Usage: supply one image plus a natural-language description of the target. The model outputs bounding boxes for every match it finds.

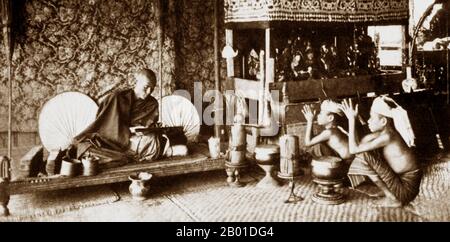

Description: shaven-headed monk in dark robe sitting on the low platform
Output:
[74,69,187,164]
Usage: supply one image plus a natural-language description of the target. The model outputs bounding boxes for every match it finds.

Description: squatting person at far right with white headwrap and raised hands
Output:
[342,96,422,207]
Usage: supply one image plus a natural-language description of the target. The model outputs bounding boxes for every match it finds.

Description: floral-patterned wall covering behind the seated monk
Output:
[0,0,175,132]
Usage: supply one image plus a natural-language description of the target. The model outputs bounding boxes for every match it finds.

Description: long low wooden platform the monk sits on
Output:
[0,144,225,216]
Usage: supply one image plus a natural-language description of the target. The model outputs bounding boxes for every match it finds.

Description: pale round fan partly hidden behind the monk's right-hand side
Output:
[161,95,200,141]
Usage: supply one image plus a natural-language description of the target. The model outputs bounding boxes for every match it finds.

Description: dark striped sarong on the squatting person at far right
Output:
[348,150,422,205]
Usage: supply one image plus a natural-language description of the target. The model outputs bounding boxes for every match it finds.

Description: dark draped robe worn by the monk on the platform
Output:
[74,89,166,163]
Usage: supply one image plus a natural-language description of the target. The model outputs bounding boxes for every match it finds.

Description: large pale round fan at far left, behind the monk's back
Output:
[39,92,98,150]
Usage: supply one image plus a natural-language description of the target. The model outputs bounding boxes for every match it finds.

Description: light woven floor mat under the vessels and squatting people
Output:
[165,162,450,222]
